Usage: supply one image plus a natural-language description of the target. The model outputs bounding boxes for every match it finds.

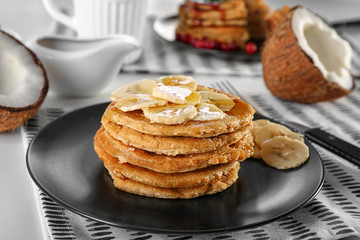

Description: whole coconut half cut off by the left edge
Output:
[0,30,49,132]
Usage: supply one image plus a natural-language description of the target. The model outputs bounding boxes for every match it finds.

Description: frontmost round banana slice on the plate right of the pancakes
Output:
[261,136,309,169]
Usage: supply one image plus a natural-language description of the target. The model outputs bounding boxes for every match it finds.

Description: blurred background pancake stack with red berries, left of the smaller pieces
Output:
[176,0,250,50]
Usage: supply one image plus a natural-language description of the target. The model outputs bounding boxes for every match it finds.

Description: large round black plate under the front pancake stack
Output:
[27,103,324,233]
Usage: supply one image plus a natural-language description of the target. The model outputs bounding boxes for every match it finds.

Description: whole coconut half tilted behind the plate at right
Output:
[262,6,354,103]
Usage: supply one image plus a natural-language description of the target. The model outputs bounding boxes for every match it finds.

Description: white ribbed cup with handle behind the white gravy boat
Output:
[42,0,148,63]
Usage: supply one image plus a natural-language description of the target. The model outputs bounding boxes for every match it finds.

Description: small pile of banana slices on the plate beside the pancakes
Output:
[251,119,309,169]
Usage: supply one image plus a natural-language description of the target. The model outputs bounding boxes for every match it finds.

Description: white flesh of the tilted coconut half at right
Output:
[291,8,353,90]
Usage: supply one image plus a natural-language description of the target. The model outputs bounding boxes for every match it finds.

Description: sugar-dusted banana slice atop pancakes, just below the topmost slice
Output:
[152,86,200,105]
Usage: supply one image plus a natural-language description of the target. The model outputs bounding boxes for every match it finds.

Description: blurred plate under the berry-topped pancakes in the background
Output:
[153,14,262,61]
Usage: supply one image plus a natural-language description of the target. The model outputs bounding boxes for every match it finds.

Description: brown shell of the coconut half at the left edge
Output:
[0,30,49,132]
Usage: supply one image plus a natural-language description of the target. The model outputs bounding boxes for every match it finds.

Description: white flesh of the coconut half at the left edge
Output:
[0,33,44,108]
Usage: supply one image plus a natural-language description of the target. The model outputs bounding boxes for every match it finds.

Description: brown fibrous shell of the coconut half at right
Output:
[262,6,354,103]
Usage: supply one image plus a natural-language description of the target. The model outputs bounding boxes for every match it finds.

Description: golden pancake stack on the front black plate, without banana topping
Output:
[94,87,254,199]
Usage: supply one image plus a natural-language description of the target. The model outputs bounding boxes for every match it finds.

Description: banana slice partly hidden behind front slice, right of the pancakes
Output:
[254,122,304,148]
